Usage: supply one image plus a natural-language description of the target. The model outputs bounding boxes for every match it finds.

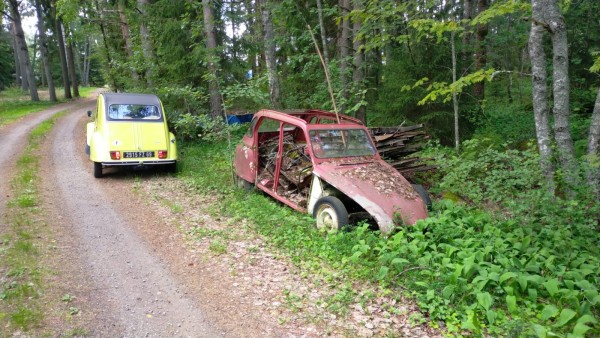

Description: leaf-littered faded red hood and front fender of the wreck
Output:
[313,160,427,234]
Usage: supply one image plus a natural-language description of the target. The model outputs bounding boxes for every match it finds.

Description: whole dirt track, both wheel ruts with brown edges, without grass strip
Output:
[0,100,288,337]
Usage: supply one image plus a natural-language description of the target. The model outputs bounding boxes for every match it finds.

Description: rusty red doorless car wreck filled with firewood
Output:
[235,110,427,235]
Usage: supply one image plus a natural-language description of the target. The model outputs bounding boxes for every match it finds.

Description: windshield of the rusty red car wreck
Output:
[309,129,375,158]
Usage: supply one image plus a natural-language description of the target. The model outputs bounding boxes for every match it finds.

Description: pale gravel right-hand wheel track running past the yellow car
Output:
[47,104,222,337]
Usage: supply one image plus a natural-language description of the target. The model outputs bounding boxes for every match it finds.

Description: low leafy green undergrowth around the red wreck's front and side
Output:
[181,131,600,337]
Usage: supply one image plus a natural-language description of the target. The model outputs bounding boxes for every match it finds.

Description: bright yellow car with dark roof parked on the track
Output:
[86,93,177,178]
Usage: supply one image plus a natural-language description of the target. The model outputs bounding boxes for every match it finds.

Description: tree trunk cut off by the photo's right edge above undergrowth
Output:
[587,88,600,201]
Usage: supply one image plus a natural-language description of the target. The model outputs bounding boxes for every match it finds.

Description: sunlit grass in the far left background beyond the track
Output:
[0,87,95,127]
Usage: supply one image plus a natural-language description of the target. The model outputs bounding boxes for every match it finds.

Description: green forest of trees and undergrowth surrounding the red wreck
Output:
[0,0,600,337]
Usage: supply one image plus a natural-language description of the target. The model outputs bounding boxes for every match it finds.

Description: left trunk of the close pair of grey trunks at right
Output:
[529,0,555,192]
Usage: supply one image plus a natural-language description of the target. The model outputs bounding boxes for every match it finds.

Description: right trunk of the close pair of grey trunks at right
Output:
[543,0,580,197]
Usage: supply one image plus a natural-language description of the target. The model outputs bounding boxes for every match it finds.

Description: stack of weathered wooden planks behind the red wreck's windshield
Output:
[369,124,435,176]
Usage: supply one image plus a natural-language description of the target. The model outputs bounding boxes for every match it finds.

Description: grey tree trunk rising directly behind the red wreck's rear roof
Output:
[260,0,281,108]
